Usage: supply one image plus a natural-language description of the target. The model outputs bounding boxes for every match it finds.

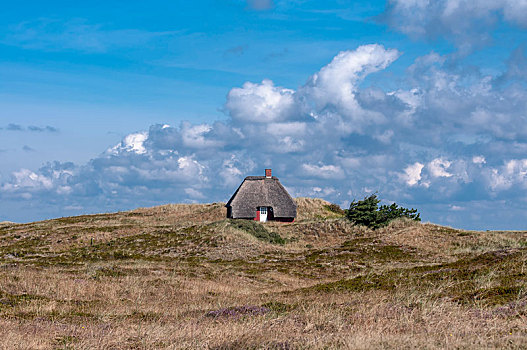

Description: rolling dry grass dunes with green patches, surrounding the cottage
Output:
[0,198,527,349]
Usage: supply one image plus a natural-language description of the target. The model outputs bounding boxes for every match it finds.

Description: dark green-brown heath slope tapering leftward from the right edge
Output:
[307,247,527,306]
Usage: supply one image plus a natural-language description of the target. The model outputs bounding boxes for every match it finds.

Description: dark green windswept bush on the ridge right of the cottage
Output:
[346,194,421,230]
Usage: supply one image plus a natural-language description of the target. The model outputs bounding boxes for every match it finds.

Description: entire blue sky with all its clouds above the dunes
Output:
[0,0,527,229]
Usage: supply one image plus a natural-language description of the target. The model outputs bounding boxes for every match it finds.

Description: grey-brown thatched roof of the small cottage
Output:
[226,176,296,219]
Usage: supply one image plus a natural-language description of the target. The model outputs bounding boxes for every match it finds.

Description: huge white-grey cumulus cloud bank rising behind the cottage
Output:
[0,45,527,227]
